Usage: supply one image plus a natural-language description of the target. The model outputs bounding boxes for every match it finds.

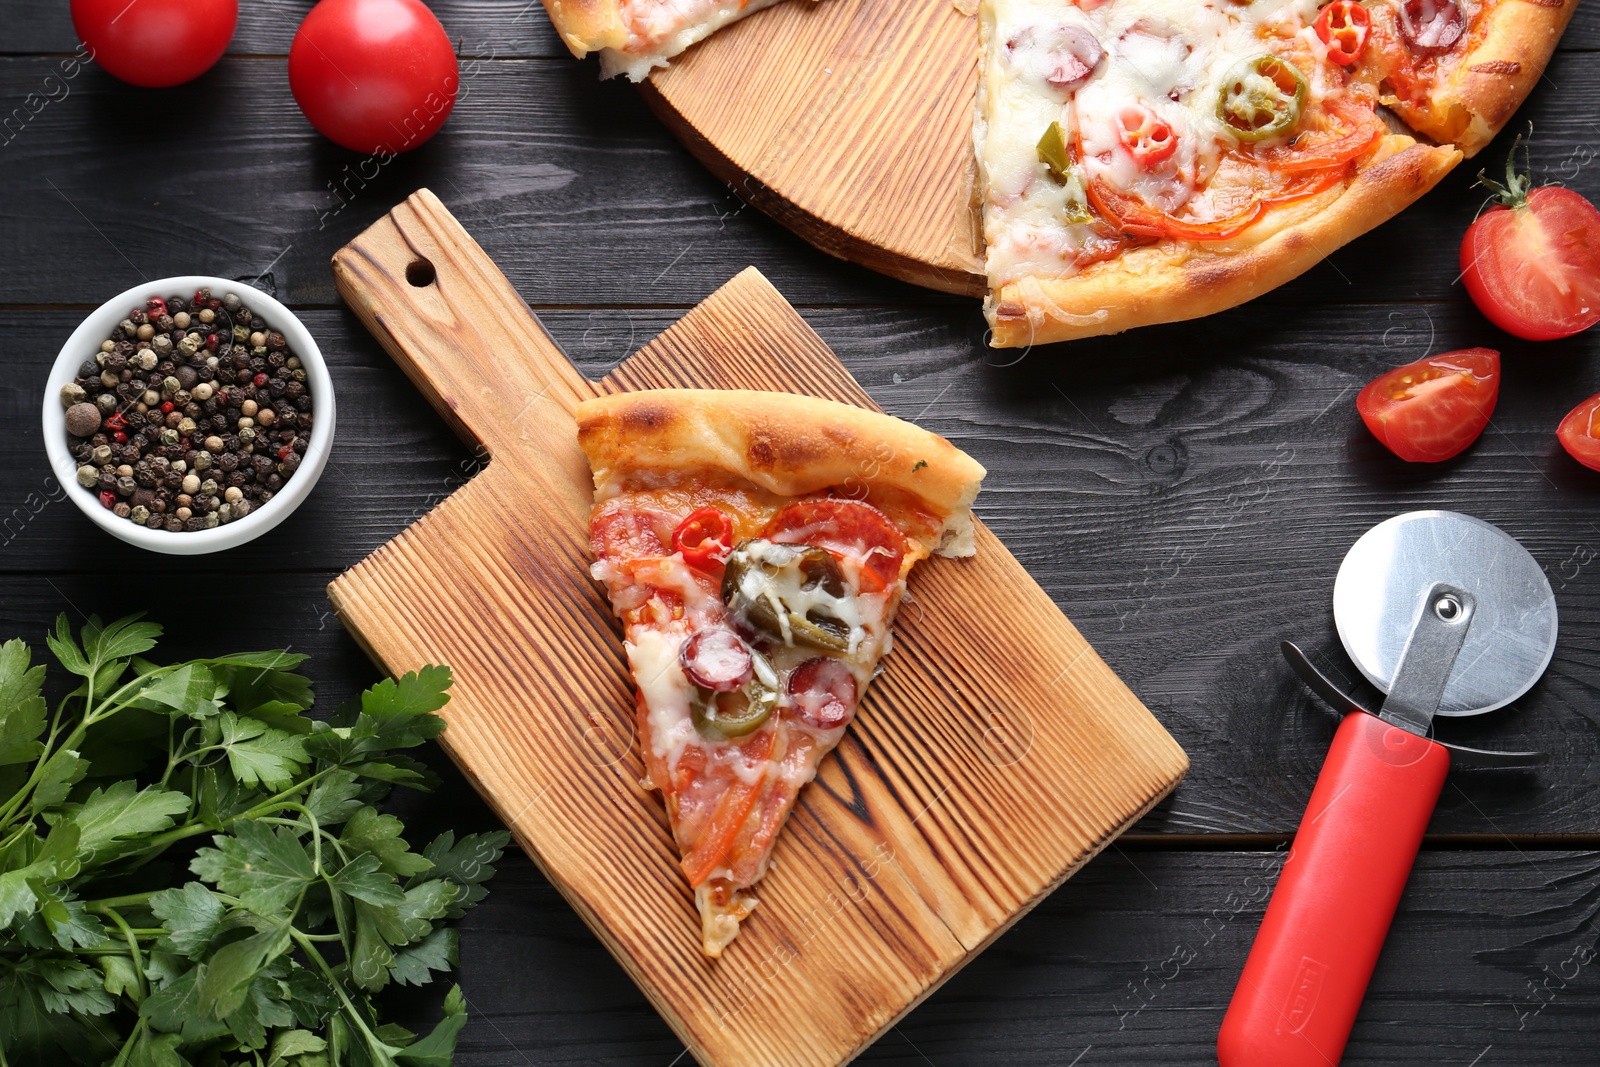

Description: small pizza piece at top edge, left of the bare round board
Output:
[544,0,806,82]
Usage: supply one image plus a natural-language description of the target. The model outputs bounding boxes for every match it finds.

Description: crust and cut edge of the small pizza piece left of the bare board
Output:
[544,0,806,82]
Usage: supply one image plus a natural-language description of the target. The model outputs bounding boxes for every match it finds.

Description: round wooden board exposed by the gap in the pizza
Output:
[642,0,984,296]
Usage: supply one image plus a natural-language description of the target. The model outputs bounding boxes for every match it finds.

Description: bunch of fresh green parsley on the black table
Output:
[0,616,507,1067]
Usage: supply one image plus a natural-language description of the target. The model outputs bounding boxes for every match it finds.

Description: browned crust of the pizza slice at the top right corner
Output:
[1384,0,1578,158]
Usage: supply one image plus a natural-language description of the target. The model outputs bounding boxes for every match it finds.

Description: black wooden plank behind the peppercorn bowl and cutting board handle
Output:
[0,52,1600,308]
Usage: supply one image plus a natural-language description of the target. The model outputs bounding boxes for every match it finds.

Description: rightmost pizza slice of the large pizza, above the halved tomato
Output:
[1357,0,1578,157]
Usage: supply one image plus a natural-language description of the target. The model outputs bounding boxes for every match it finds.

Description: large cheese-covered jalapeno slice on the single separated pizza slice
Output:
[722,537,850,653]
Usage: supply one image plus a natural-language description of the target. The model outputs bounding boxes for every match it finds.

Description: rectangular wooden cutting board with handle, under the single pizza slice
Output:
[328,190,1189,1067]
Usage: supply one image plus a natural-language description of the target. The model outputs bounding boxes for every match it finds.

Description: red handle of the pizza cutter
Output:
[1216,712,1450,1067]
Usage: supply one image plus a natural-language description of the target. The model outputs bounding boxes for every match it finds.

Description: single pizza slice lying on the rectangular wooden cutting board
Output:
[578,389,984,957]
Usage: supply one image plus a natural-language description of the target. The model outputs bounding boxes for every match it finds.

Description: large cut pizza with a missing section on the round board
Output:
[546,0,1576,347]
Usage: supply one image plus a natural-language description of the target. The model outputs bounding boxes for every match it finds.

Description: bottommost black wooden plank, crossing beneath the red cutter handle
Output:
[456,849,1600,1067]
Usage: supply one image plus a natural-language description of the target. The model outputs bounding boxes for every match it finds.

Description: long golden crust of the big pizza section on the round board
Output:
[984,134,1461,349]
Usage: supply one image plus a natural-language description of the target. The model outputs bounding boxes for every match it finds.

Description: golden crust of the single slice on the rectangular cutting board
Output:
[578,389,984,555]
